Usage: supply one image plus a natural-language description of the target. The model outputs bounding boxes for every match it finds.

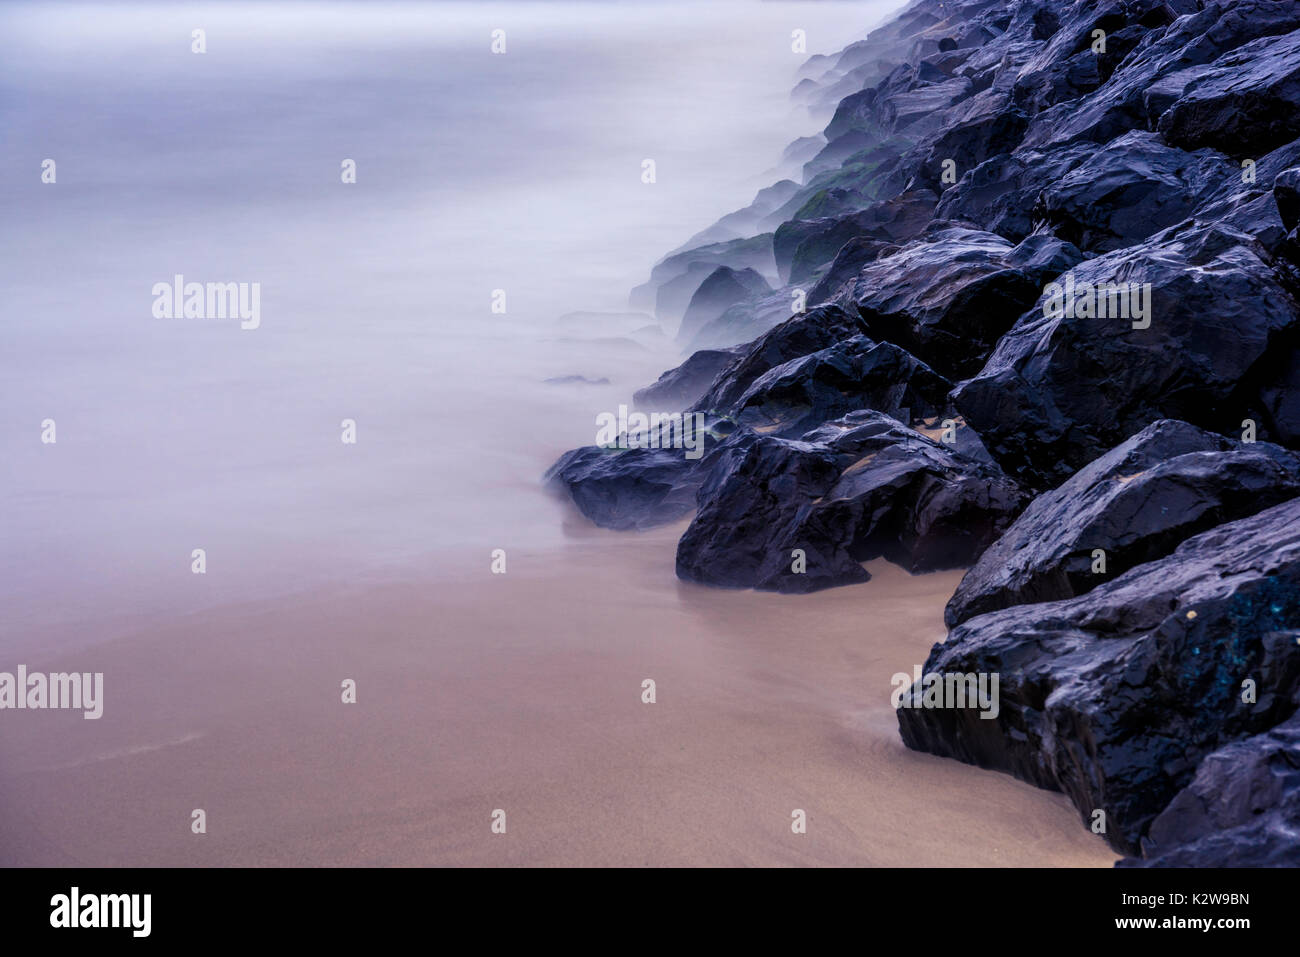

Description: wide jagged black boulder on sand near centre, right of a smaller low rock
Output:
[677,411,1024,593]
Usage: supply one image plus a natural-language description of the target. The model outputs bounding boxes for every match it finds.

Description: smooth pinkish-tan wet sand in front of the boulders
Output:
[0,528,1114,866]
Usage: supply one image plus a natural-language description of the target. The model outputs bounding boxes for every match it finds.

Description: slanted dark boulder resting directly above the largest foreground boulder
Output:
[944,419,1300,628]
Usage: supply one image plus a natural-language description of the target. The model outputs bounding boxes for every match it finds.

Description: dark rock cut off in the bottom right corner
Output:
[1117,715,1300,867]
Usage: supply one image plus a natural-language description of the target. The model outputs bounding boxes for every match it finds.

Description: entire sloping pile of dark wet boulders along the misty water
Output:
[551,0,1300,866]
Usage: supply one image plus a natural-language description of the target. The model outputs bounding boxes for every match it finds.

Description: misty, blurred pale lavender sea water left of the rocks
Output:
[0,0,901,651]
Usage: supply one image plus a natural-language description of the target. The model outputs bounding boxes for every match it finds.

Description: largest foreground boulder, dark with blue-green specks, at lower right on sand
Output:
[898,499,1300,854]
